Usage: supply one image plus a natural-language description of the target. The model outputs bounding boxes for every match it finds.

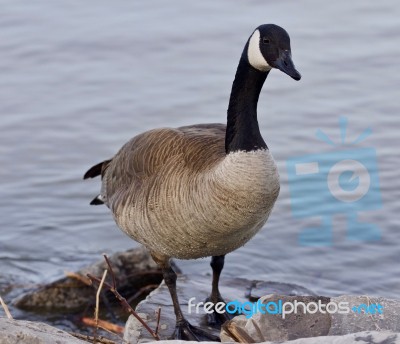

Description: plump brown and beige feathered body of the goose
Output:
[94,124,279,259]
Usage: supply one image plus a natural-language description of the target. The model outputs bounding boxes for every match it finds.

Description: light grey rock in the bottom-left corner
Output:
[0,318,87,344]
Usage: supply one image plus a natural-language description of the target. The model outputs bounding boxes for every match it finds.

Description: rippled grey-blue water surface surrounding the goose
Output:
[0,0,400,318]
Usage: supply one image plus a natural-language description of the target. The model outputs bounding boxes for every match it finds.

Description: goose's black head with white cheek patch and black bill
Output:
[247,24,301,80]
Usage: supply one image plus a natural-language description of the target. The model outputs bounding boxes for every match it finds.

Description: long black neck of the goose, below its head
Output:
[225,56,269,154]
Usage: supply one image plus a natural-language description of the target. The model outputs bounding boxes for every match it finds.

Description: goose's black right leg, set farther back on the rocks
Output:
[206,256,233,327]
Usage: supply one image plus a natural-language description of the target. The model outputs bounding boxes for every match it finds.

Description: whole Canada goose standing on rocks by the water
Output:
[84,24,301,340]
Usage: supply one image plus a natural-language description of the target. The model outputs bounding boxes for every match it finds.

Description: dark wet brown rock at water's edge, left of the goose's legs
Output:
[15,247,177,312]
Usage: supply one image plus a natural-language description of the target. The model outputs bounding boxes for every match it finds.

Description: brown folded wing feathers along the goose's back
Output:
[101,124,226,210]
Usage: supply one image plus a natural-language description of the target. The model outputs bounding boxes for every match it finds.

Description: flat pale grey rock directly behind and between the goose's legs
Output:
[125,275,313,343]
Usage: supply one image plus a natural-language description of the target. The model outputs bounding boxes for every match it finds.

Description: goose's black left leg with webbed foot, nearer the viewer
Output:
[153,256,220,342]
